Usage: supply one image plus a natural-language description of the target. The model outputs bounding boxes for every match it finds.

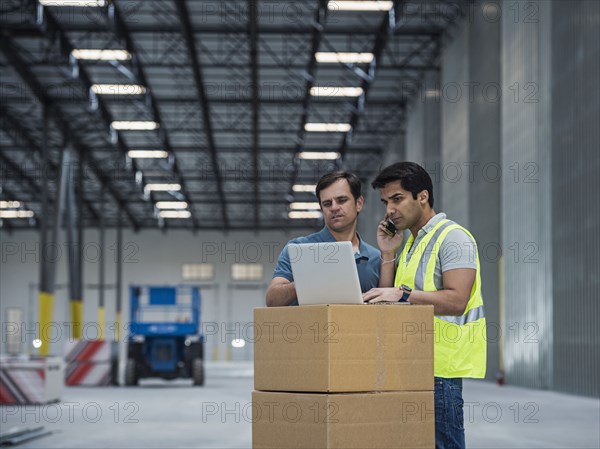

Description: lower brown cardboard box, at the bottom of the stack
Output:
[252,391,435,449]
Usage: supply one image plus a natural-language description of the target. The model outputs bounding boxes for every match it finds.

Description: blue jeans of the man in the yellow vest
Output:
[434,377,465,449]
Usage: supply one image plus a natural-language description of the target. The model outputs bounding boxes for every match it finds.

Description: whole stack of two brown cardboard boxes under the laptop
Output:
[252,304,435,448]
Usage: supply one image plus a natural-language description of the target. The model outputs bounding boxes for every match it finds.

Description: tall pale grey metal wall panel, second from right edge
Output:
[501,1,553,388]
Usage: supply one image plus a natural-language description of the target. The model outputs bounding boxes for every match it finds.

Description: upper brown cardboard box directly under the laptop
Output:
[254,304,434,392]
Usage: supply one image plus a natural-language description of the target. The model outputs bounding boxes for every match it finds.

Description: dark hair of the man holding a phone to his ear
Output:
[371,162,433,207]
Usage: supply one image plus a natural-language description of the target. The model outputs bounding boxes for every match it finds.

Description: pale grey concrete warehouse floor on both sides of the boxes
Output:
[0,363,600,449]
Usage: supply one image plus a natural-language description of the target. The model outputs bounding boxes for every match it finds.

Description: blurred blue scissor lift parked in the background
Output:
[125,285,204,385]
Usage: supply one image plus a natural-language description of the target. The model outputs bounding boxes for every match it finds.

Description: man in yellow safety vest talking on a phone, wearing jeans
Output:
[363,162,486,449]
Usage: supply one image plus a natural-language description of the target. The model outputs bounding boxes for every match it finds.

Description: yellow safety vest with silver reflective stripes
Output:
[394,219,487,378]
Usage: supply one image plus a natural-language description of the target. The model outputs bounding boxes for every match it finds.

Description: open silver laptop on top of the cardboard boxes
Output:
[288,242,364,305]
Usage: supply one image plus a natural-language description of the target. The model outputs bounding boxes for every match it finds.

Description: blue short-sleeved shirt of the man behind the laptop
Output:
[273,227,381,306]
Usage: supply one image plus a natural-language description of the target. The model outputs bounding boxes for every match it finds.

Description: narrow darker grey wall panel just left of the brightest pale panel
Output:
[467,2,502,379]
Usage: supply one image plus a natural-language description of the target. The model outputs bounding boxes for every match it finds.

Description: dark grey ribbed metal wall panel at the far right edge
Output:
[552,1,600,396]
